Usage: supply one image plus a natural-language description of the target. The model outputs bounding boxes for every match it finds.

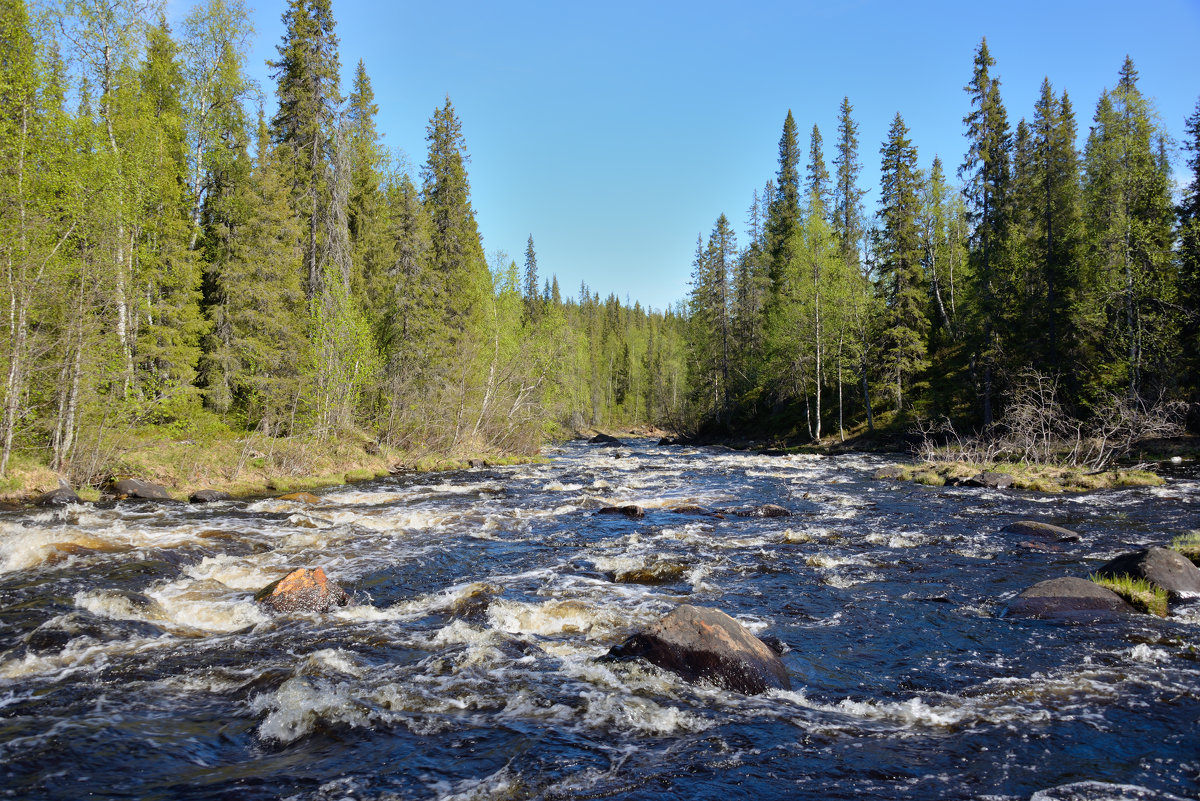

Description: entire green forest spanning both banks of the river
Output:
[0,0,1200,491]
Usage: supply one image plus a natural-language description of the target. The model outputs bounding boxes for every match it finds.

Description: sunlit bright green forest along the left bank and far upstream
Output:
[0,0,686,481]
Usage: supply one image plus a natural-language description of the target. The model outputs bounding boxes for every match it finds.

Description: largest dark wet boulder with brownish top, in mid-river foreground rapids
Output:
[605,604,792,695]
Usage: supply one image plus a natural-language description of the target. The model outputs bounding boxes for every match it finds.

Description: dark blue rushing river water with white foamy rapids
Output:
[0,441,1200,801]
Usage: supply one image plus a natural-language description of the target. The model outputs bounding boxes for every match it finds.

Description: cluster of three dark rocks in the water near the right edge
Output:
[1003,520,1200,622]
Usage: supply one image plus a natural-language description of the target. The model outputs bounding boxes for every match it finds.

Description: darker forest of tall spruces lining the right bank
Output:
[686,40,1200,439]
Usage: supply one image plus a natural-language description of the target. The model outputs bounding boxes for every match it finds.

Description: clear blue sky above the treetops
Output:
[220,0,1200,308]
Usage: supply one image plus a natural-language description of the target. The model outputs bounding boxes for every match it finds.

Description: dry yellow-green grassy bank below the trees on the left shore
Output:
[0,428,539,504]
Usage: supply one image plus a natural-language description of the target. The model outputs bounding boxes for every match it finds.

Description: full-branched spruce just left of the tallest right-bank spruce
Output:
[880,113,929,411]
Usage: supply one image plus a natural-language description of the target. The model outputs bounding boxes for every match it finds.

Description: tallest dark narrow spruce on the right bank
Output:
[959,38,1010,426]
